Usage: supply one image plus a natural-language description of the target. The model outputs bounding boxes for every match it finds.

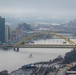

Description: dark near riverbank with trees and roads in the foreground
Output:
[0,50,76,75]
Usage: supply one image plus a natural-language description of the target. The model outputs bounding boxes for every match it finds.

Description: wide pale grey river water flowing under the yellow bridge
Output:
[0,39,76,73]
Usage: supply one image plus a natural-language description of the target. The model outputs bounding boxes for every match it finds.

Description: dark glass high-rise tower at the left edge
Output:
[0,17,5,43]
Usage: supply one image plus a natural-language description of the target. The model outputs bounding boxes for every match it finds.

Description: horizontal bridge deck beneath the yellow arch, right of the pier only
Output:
[14,44,76,48]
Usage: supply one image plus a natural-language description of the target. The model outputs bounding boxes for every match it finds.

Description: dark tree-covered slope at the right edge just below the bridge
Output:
[63,49,76,63]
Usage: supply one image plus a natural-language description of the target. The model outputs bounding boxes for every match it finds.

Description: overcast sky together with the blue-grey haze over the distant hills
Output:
[0,0,76,23]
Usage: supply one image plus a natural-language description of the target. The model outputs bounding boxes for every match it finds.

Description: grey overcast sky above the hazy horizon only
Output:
[0,0,76,18]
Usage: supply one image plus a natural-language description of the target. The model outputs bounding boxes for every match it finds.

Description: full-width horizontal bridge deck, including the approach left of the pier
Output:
[0,44,76,48]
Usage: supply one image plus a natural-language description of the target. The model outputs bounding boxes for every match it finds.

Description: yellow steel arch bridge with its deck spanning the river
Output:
[3,32,76,48]
